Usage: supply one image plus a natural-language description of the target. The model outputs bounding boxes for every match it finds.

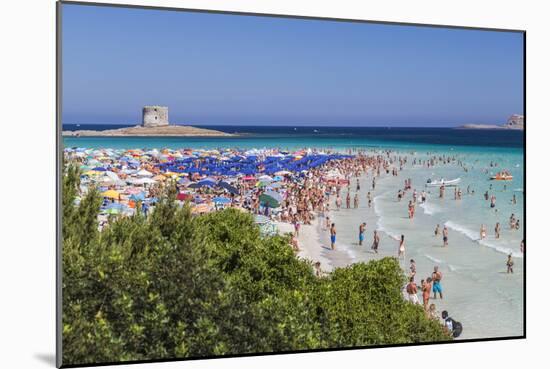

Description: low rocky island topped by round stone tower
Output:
[61,105,234,137]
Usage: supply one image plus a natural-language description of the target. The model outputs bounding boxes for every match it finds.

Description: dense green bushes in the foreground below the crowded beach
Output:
[62,165,450,365]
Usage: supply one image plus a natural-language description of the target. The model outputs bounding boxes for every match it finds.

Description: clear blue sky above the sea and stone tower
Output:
[62,4,523,126]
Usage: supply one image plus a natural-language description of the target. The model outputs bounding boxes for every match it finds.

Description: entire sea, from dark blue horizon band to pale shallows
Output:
[63,126,524,338]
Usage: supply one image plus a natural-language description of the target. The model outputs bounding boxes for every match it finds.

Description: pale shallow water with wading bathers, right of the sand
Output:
[331,150,523,338]
